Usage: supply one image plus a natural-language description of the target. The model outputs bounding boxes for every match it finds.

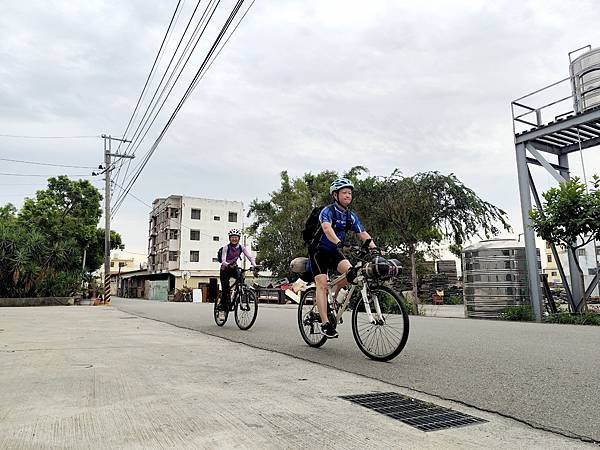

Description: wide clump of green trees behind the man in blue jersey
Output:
[249,166,510,309]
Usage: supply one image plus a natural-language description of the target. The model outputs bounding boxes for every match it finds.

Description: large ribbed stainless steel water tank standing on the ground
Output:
[462,239,541,319]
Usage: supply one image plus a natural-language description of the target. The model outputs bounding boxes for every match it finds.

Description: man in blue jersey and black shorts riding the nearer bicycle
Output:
[308,178,379,338]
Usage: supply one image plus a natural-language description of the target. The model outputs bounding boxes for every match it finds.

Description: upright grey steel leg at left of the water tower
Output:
[516,143,542,322]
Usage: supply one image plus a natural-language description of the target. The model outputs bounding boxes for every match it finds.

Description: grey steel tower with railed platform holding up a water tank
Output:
[511,65,600,321]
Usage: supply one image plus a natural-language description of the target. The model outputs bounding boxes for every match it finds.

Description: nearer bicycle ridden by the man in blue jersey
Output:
[298,246,409,361]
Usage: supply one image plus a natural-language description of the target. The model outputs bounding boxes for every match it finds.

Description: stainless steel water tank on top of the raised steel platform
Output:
[569,48,600,113]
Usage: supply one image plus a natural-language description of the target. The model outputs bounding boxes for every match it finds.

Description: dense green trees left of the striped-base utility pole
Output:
[0,176,124,297]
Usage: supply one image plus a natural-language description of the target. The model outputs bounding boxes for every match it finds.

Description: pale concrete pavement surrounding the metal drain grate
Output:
[0,306,593,449]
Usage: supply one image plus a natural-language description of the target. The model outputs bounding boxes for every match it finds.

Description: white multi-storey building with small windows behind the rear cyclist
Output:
[148,195,255,298]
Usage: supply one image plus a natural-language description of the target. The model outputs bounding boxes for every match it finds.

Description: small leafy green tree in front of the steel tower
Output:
[529,175,600,312]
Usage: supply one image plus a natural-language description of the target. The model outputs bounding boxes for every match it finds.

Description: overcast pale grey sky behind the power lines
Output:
[0,0,600,260]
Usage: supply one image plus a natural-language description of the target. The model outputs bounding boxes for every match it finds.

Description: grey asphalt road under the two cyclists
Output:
[113,298,600,442]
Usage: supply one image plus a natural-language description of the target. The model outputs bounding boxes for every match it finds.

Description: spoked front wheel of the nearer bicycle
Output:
[352,286,409,361]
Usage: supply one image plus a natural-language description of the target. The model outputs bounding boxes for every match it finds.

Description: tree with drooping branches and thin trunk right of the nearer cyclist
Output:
[356,171,510,314]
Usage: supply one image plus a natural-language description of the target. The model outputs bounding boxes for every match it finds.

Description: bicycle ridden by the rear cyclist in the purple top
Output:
[213,269,258,330]
